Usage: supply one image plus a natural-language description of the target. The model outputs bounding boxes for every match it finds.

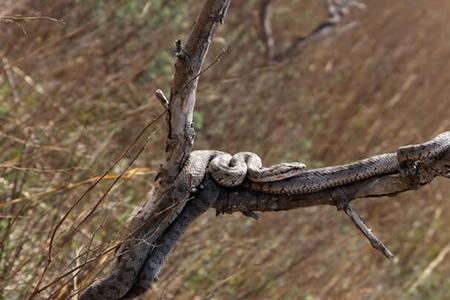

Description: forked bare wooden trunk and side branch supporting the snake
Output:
[80,0,450,300]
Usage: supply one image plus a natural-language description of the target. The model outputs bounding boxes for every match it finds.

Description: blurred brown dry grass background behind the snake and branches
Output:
[0,0,450,300]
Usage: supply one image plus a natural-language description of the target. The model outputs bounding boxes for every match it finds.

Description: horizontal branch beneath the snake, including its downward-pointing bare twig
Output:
[214,144,450,258]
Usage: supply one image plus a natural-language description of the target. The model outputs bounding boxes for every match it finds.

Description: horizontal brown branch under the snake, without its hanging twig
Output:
[214,156,450,213]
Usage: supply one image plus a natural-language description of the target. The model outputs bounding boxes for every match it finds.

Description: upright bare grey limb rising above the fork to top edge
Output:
[160,0,231,185]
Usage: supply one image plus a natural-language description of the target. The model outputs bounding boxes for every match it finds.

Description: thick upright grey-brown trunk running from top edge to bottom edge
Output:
[81,0,231,299]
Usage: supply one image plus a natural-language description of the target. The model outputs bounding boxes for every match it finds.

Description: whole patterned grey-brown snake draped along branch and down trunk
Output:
[81,132,450,300]
